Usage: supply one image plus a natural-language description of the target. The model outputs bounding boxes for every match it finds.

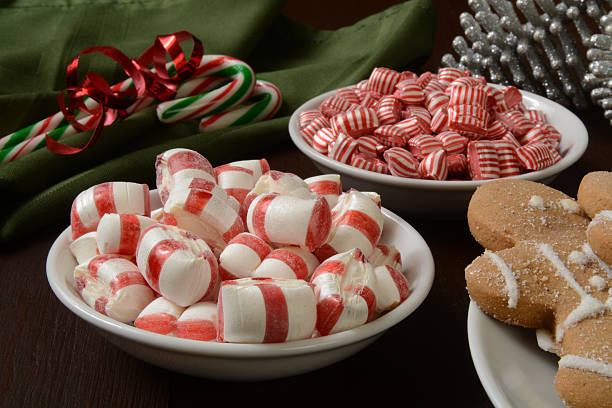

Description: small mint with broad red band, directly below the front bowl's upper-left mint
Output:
[96,214,157,256]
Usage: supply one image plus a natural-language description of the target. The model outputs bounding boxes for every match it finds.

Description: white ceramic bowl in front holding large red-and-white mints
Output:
[47,191,434,381]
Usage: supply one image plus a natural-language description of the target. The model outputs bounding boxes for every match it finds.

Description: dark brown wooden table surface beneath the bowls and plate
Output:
[0,0,612,407]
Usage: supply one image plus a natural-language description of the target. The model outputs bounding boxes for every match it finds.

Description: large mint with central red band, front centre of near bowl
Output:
[217,278,317,343]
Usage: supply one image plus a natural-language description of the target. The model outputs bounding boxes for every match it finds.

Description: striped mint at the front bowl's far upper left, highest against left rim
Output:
[70,181,151,240]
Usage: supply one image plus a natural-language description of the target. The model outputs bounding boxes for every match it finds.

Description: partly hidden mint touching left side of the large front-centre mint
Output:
[174,302,217,341]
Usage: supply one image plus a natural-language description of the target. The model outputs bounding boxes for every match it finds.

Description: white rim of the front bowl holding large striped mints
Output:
[46,208,434,359]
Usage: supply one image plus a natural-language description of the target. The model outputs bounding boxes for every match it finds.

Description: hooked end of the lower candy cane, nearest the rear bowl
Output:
[199,79,282,132]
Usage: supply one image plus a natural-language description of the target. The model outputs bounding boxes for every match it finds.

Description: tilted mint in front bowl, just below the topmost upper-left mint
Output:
[164,182,246,251]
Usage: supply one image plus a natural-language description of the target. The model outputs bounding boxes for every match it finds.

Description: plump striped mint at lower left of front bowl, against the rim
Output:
[74,254,155,323]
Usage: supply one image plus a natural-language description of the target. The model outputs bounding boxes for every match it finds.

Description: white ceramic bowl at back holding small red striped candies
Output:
[289,85,588,215]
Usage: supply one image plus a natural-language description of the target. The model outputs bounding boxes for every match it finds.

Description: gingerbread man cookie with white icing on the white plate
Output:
[465,172,612,408]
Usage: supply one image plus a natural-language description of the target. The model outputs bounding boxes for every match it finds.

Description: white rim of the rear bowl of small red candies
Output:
[289,83,589,191]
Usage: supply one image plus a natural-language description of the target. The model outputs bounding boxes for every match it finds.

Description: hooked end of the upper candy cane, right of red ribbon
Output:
[157,55,255,123]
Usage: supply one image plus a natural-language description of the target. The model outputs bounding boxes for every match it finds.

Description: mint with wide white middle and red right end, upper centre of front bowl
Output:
[246,194,331,251]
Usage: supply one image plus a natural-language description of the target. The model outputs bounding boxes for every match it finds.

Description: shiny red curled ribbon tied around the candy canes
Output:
[45,31,204,155]
